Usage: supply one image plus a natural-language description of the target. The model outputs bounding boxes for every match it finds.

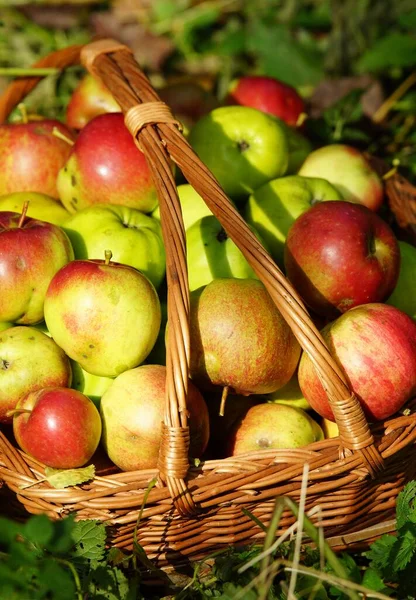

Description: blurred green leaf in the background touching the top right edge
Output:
[357,32,416,73]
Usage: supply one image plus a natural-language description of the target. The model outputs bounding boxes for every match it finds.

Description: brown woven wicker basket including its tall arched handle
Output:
[0,40,416,568]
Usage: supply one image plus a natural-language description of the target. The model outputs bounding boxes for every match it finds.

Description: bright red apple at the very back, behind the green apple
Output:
[225,75,305,126]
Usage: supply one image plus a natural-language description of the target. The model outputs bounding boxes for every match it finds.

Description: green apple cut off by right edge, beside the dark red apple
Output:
[386,240,416,319]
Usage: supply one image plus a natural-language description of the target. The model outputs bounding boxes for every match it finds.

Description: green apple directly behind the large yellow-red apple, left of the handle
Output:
[62,204,166,287]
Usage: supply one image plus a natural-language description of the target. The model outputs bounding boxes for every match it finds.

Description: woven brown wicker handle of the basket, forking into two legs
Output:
[0,40,384,514]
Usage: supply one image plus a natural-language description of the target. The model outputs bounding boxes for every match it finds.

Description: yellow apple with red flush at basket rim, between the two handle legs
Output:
[227,402,324,456]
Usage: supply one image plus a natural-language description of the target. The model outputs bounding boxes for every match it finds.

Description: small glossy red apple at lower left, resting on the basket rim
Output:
[13,387,101,469]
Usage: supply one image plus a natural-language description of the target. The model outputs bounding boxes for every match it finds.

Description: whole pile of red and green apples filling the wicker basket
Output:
[0,69,416,470]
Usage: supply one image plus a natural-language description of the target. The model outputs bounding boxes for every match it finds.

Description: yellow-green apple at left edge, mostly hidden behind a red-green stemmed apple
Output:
[0,192,69,225]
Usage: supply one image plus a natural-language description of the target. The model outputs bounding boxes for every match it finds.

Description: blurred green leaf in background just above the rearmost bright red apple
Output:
[247,21,323,87]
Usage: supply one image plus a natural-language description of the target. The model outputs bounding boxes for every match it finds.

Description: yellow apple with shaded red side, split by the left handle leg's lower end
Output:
[100,365,209,471]
